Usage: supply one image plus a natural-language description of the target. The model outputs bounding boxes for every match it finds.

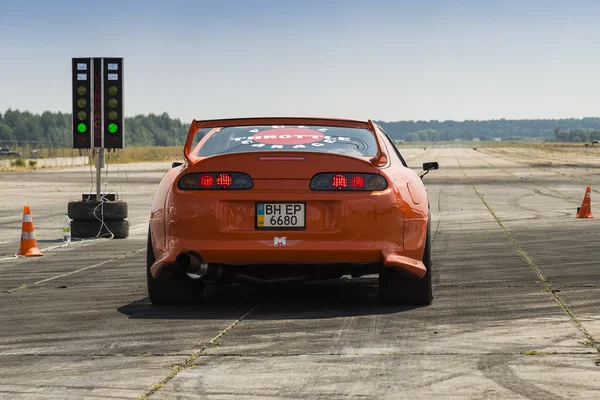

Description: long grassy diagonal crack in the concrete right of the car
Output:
[453,150,600,352]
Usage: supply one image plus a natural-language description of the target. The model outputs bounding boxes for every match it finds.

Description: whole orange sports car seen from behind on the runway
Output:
[147,118,438,305]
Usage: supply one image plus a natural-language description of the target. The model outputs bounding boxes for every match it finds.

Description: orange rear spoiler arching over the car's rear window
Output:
[183,117,387,165]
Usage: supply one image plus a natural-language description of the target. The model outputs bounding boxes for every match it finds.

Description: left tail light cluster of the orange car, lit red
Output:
[177,172,253,190]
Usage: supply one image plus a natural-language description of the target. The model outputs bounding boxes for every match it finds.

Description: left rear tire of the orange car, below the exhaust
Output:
[146,229,204,306]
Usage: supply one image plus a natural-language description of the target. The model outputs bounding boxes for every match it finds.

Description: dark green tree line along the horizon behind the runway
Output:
[0,109,600,147]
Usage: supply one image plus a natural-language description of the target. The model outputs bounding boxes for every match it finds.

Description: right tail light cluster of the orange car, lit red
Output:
[309,172,387,192]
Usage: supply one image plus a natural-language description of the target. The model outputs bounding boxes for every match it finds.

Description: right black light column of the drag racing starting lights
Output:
[102,58,125,149]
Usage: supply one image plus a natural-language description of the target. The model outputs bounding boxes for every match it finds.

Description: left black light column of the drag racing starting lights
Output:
[72,58,92,149]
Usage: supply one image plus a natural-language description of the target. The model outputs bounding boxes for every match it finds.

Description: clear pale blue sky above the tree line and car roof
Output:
[0,0,600,121]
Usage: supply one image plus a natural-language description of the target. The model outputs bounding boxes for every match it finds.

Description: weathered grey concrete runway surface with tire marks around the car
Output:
[0,148,600,400]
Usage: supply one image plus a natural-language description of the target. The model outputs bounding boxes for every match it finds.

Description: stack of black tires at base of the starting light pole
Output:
[67,200,129,239]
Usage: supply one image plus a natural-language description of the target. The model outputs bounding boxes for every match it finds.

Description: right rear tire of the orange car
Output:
[379,217,433,305]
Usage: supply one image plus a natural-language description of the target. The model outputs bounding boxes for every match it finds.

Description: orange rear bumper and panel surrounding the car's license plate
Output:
[150,186,427,278]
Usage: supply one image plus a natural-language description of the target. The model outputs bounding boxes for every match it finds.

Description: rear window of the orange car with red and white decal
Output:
[198,125,377,157]
